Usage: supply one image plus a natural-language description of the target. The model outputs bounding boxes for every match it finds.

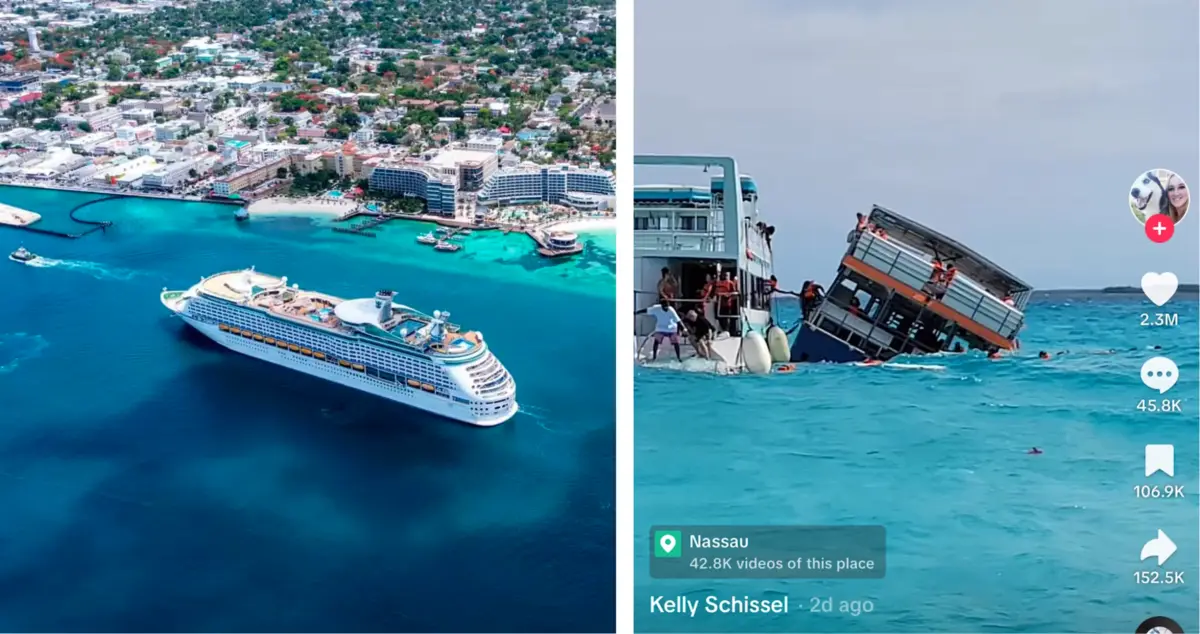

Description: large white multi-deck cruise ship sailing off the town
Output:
[161,268,517,426]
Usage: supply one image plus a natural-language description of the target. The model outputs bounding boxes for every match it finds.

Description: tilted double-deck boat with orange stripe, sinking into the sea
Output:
[791,205,1033,363]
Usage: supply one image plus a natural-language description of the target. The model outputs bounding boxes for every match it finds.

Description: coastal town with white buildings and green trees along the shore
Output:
[0,0,616,256]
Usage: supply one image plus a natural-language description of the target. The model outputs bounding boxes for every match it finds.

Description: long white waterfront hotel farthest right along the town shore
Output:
[479,163,617,209]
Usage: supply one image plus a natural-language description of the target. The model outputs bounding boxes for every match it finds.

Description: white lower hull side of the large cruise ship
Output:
[176,312,517,427]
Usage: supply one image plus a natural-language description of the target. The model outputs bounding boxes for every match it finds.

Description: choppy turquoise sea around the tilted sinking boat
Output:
[634,295,1200,633]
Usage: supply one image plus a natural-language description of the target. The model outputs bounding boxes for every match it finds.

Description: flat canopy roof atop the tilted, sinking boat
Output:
[870,205,1033,293]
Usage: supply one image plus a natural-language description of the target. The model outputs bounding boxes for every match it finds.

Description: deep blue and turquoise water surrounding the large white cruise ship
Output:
[0,187,616,632]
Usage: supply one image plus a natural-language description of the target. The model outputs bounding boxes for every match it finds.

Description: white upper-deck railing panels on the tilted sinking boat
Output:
[851,232,1025,339]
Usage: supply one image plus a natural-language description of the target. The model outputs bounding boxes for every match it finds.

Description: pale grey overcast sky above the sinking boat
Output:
[634,0,1200,288]
